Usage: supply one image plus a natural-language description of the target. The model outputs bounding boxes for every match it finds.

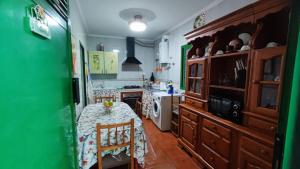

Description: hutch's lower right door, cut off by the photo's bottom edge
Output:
[239,150,272,169]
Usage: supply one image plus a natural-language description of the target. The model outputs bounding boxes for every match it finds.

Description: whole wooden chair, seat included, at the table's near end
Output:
[97,119,135,169]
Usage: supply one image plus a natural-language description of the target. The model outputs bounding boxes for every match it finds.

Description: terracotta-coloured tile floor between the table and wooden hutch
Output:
[143,119,201,169]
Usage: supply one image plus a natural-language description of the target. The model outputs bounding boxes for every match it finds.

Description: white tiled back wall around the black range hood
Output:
[87,36,154,88]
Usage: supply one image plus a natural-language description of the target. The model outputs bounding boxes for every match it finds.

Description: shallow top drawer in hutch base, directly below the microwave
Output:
[203,119,231,140]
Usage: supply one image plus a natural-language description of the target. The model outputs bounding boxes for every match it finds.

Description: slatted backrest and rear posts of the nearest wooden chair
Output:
[97,119,134,169]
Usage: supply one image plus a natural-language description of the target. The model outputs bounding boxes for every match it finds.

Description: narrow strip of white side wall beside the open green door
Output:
[70,0,87,116]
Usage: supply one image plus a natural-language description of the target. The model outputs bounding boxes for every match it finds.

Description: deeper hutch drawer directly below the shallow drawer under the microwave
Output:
[201,128,230,159]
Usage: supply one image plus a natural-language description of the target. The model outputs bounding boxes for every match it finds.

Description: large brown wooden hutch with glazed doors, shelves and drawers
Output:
[178,0,290,169]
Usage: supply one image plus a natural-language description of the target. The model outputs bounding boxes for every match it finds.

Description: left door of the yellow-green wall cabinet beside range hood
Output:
[89,51,104,74]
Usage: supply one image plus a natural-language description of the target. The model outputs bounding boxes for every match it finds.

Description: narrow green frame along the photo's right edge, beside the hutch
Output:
[279,0,300,169]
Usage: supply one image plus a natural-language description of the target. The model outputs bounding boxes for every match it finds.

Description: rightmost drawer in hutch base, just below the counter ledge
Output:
[241,136,273,163]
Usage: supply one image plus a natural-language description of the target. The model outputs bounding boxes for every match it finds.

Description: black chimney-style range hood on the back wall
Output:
[122,37,142,65]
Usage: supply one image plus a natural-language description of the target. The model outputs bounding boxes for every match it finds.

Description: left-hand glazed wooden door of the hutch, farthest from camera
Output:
[186,58,206,99]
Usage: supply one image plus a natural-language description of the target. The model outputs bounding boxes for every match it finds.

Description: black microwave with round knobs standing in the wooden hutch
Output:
[208,95,242,124]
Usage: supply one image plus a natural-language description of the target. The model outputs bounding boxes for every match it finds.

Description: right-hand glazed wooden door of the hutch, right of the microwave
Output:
[249,47,286,118]
